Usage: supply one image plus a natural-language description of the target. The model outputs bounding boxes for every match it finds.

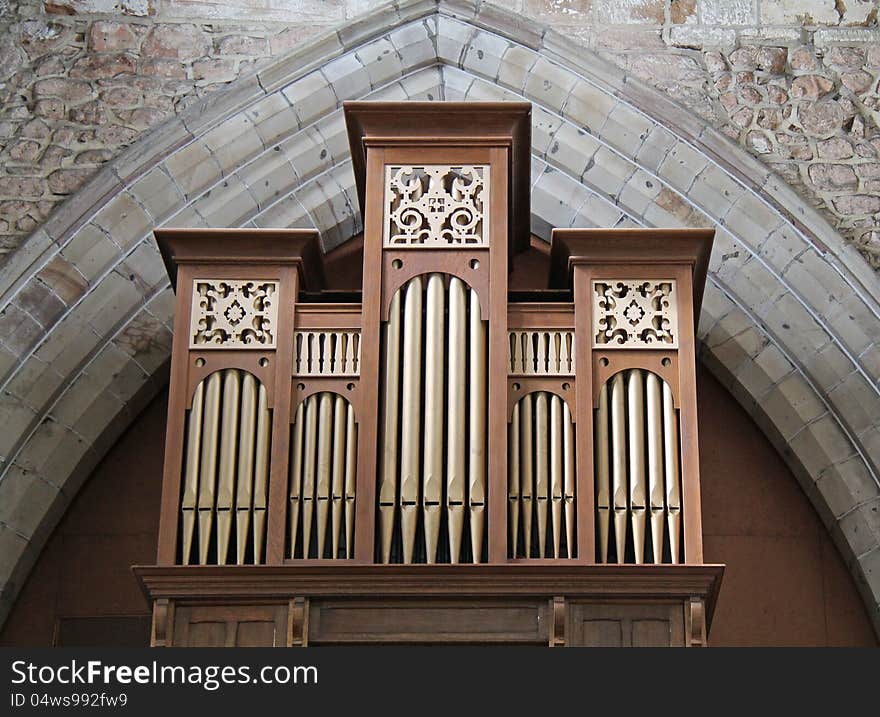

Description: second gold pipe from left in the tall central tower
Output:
[400,276,422,563]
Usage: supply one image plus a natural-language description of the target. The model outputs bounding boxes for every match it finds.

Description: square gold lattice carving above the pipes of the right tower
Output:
[593,279,678,349]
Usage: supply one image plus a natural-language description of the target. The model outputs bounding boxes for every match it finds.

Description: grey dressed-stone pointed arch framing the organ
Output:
[0,0,880,627]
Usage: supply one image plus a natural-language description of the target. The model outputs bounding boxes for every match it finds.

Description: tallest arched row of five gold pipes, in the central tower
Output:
[377,273,488,563]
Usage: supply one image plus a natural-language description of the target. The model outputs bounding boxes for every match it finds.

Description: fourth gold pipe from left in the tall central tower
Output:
[446,277,467,563]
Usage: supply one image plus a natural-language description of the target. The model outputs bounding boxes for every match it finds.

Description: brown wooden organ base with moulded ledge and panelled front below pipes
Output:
[134,564,724,646]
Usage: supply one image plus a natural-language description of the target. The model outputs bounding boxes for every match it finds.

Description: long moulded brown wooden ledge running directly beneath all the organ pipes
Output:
[132,563,724,622]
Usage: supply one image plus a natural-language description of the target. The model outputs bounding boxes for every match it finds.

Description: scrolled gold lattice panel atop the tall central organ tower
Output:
[384,164,489,246]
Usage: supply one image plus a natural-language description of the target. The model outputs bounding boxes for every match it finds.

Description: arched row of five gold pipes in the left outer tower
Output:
[181,369,271,565]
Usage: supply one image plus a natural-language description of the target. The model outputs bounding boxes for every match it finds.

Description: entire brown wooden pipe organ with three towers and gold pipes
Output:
[134,102,723,646]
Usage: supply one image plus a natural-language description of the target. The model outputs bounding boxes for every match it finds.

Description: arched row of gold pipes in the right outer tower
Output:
[594,369,681,565]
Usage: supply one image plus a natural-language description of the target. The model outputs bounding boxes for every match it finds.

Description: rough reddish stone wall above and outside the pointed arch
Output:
[0,0,880,269]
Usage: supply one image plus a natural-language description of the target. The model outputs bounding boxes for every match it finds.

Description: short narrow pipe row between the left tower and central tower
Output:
[288,391,357,559]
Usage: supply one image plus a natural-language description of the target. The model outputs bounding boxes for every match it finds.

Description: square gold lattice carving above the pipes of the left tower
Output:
[189,279,278,349]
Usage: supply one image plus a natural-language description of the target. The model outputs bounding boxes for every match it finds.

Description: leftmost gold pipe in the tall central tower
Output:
[379,291,400,563]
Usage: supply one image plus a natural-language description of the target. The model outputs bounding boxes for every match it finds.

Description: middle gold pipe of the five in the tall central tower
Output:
[422,274,446,563]
